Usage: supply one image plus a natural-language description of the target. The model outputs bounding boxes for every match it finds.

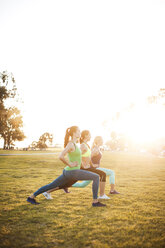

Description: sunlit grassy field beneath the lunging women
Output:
[0,152,165,248]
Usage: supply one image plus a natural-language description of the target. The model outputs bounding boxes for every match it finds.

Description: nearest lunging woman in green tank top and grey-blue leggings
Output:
[27,126,106,207]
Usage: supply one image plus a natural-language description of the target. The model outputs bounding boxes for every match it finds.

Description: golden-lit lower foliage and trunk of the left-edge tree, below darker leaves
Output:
[0,107,25,149]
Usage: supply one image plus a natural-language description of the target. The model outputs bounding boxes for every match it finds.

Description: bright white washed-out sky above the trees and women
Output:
[0,0,165,145]
